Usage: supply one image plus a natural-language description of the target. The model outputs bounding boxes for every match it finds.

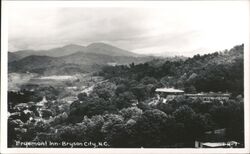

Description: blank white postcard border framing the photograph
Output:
[0,0,250,154]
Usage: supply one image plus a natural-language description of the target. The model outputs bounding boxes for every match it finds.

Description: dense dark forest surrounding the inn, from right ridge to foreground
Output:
[8,45,244,148]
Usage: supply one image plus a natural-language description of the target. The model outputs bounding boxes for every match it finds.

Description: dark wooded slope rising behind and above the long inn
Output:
[100,45,244,95]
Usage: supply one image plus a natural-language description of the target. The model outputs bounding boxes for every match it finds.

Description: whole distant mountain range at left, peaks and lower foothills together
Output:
[8,43,154,74]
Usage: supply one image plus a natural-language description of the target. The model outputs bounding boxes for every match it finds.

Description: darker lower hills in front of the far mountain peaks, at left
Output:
[8,52,153,74]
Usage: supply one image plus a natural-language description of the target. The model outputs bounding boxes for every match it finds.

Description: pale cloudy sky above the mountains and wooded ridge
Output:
[8,1,249,55]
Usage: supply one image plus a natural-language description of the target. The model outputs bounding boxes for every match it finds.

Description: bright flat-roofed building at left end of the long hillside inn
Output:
[155,88,184,103]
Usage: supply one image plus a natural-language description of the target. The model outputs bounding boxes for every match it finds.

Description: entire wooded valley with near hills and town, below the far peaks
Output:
[8,44,244,148]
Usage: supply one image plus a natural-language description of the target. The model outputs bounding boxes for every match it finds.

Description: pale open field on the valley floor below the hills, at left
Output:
[8,73,103,100]
